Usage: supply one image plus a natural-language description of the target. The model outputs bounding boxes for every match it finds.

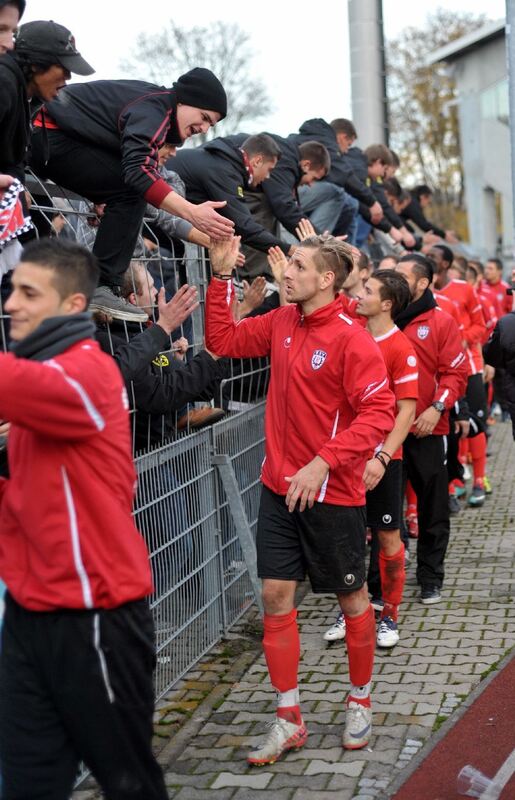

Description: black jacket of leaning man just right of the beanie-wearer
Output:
[167,136,290,253]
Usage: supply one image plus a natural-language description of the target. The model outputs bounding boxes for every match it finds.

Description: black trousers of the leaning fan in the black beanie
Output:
[30,128,146,286]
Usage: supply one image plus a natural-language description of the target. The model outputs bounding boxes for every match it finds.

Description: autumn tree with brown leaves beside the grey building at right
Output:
[387,8,486,233]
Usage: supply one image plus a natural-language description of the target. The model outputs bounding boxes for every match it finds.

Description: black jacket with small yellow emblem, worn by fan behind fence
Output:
[96,323,227,450]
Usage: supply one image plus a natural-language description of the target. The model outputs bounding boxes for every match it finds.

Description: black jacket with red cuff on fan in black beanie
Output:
[46,81,182,207]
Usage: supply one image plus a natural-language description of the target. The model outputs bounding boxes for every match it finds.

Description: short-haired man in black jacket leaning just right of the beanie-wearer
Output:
[167,133,291,268]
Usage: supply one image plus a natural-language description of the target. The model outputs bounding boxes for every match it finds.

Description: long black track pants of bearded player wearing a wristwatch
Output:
[402,433,450,588]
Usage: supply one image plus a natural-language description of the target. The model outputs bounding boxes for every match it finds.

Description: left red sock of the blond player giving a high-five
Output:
[263,608,302,725]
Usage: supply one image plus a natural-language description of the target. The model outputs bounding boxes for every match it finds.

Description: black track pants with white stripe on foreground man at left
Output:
[0,595,168,800]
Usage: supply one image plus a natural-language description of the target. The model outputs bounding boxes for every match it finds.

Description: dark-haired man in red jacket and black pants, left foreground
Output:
[0,239,168,800]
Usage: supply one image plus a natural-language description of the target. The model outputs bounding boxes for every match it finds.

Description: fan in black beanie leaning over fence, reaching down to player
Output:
[31,67,233,322]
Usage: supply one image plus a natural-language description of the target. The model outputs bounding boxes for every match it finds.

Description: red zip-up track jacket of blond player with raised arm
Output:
[206,279,395,506]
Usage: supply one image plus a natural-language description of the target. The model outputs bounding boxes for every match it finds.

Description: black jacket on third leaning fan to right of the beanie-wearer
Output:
[294,118,375,207]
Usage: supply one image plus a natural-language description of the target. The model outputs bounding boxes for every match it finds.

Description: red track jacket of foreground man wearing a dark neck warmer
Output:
[0,339,152,611]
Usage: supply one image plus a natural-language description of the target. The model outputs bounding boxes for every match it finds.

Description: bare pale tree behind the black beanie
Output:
[121,20,271,141]
